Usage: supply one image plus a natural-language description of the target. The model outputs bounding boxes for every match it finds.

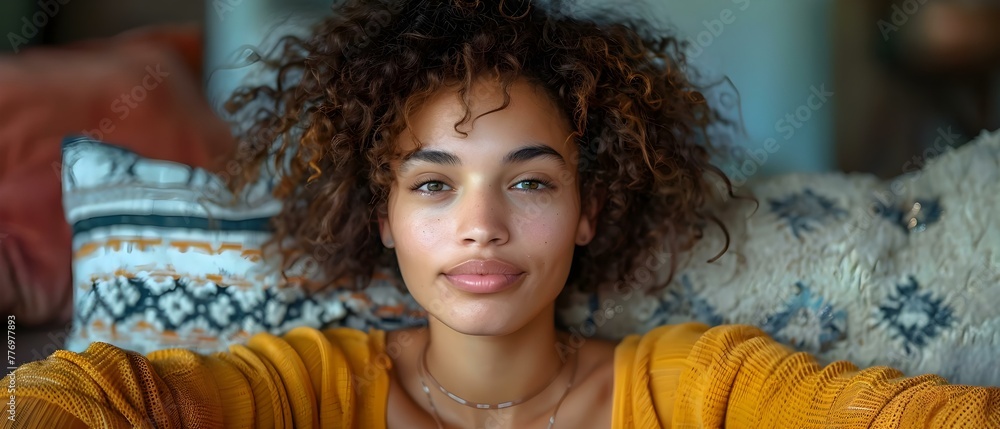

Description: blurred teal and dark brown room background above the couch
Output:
[0,0,1000,183]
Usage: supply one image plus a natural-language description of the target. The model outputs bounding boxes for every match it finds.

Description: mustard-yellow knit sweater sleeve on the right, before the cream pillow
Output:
[616,324,1000,429]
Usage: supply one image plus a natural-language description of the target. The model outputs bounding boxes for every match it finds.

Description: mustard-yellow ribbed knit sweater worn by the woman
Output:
[2,323,1000,429]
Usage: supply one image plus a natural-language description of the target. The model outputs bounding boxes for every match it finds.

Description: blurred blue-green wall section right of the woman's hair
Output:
[648,0,837,175]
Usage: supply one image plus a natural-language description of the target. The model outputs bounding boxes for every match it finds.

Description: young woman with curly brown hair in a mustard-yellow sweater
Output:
[4,0,1000,428]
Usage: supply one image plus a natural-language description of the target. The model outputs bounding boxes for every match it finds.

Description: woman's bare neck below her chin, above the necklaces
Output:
[426,306,570,415]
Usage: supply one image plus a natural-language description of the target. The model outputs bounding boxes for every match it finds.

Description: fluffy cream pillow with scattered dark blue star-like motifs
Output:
[561,132,1000,386]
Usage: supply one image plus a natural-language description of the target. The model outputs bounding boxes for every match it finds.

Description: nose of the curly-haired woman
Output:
[456,187,510,246]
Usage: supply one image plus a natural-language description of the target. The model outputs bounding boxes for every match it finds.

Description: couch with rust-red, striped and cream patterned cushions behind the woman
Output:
[0,28,1000,385]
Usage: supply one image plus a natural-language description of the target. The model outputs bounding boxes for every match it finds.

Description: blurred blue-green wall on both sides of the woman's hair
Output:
[205,0,837,178]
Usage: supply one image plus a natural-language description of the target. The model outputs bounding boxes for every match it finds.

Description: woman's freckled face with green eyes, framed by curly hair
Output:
[379,80,594,335]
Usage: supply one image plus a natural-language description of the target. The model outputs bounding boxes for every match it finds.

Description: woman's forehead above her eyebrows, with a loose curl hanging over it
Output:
[397,78,576,159]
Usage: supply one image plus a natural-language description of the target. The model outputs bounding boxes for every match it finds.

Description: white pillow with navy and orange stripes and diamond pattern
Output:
[63,138,424,353]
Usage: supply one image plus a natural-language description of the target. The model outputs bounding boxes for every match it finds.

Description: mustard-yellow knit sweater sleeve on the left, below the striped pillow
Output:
[0,328,391,429]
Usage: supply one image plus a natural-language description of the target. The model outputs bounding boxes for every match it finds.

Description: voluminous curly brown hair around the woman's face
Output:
[229,0,732,289]
